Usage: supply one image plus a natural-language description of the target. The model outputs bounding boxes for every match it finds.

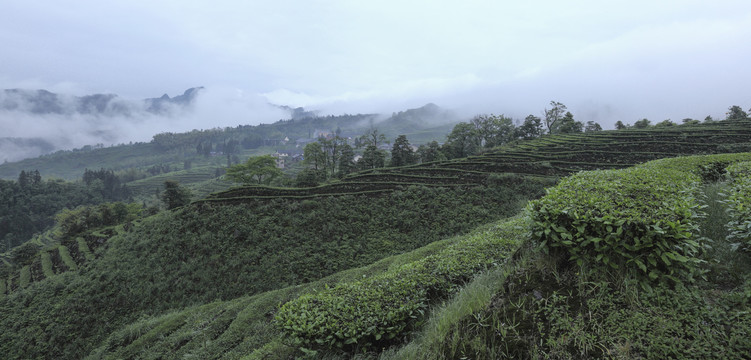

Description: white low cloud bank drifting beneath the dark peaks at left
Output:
[0,88,289,162]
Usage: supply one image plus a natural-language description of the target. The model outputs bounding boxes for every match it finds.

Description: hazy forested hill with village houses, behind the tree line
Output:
[0,102,460,180]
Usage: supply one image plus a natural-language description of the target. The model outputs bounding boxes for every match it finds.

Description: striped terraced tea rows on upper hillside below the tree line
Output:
[206,121,751,202]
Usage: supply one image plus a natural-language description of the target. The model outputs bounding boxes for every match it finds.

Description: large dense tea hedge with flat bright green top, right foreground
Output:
[528,167,701,284]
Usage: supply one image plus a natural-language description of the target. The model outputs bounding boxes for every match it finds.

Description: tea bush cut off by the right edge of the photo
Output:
[725,162,751,251]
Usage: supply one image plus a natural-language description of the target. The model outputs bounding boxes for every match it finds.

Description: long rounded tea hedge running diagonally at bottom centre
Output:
[275,219,523,352]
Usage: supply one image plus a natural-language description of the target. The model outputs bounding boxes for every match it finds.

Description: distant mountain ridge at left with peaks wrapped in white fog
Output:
[0,87,292,162]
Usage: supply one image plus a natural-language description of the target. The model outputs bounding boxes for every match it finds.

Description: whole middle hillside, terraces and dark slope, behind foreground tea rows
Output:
[0,123,751,358]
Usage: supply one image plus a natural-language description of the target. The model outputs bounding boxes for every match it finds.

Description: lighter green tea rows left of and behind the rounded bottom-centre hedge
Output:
[87,224,496,359]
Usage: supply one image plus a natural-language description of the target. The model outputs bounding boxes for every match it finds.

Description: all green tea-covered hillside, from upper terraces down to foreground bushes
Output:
[0,116,751,358]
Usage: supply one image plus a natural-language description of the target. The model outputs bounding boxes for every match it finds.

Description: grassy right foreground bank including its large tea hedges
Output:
[394,154,751,359]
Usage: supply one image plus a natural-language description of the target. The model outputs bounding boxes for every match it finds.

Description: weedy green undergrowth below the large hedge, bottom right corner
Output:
[446,266,751,359]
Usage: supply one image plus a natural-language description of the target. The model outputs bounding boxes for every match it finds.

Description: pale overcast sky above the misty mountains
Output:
[0,0,751,131]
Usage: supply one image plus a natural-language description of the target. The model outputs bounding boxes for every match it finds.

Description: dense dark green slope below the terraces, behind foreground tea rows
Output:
[0,184,542,358]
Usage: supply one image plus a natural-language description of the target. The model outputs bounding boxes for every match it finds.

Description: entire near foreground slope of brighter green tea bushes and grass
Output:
[78,153,751,359]
